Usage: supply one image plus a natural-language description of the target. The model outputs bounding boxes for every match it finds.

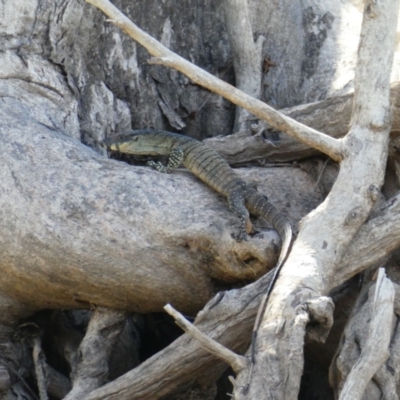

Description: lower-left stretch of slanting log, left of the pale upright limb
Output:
[81,272,273,400]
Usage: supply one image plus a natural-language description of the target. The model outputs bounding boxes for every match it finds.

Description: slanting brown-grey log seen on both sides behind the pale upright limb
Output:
[80,190,400,400]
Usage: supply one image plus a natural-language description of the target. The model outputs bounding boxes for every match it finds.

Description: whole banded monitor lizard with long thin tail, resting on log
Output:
[104,129,292,363]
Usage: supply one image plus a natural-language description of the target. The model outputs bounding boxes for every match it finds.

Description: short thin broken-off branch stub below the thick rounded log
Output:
[164,304,248,373]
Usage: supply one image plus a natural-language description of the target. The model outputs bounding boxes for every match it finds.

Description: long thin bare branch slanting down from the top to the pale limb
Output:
[86,0,343,161]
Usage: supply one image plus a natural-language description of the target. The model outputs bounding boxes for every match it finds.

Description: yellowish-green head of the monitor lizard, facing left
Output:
[103,130,171,155]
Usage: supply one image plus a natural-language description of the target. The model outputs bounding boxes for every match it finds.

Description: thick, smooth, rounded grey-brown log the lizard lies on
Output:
[0,98,322,320]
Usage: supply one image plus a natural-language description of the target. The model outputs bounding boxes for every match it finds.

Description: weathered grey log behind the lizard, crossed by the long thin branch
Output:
[205,83,400,165]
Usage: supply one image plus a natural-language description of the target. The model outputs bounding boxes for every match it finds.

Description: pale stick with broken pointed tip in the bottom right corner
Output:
[339,268,394,400]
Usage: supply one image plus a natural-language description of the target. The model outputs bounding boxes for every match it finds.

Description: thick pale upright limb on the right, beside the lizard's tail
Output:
[235,0,398,399]
